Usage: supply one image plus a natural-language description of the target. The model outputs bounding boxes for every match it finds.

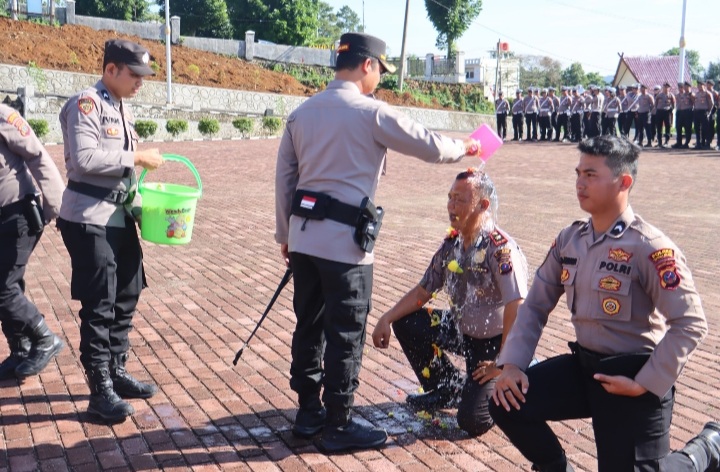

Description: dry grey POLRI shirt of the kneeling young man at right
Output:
[498,206,708,397]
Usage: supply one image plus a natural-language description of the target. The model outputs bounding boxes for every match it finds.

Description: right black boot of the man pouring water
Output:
[319,406,387,454]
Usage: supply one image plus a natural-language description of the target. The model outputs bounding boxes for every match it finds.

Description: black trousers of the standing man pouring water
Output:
[290,252,373,409]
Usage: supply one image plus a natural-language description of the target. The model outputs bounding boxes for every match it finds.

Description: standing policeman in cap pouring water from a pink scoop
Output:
[275,33,479,452]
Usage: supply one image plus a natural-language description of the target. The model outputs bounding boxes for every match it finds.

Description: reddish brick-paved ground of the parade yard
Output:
[0,135,720,472]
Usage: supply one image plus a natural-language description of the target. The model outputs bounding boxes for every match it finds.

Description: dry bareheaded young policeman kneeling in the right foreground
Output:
[490,136,720,472]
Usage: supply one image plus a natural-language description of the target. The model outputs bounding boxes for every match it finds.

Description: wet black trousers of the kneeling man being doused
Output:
[393,309,502,436]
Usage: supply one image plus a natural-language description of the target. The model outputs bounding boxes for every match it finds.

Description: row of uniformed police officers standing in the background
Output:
[495,80,720,150]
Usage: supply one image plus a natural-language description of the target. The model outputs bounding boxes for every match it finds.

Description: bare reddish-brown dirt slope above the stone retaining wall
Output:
[0,18,428,106]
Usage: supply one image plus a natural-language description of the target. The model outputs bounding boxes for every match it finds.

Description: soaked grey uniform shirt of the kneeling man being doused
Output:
[420,229,528,339]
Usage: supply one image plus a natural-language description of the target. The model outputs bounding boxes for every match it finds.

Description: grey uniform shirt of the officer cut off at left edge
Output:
[0,104,65,220]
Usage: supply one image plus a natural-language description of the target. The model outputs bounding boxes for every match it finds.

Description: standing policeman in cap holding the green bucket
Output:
[58,39,163,422]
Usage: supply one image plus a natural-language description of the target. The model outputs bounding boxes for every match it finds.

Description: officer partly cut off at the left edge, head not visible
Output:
[0,104,65,380]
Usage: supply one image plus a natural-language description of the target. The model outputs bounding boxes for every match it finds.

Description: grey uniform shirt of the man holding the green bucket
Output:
[60,81,141,227]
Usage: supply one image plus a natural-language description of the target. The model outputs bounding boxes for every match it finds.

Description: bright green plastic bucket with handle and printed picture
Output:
[138,154,202,246]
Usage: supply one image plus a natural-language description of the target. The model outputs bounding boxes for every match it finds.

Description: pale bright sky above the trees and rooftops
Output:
[324,0,720,76]
